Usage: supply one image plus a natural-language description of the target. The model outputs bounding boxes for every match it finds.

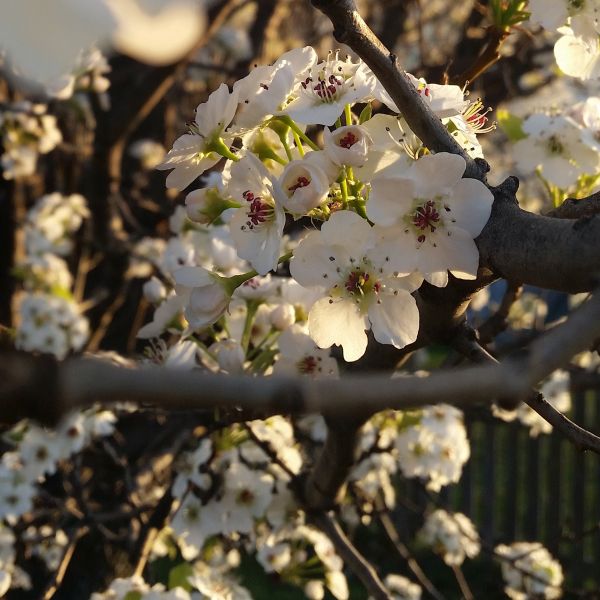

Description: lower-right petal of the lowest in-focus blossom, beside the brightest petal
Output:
[369,290,419,348]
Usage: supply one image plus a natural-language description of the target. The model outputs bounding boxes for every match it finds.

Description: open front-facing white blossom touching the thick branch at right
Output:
[367,152,493,287]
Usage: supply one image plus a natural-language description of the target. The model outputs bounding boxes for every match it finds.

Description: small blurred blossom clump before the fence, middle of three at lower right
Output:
[419,509,481,566]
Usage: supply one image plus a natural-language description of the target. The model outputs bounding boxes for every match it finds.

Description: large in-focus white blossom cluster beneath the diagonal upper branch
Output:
[148,47,492,361]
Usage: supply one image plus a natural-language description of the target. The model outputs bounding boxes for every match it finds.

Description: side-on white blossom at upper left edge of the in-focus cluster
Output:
[156,83,237,190]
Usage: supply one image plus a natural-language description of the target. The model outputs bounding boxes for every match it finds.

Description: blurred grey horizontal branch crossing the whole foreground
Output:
[0,294,600,423]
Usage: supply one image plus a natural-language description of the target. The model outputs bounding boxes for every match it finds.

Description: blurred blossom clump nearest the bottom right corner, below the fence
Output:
[495,542,564,600]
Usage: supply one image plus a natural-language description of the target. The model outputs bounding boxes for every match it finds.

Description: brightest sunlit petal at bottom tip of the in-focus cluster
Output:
[308,298,368,362]
